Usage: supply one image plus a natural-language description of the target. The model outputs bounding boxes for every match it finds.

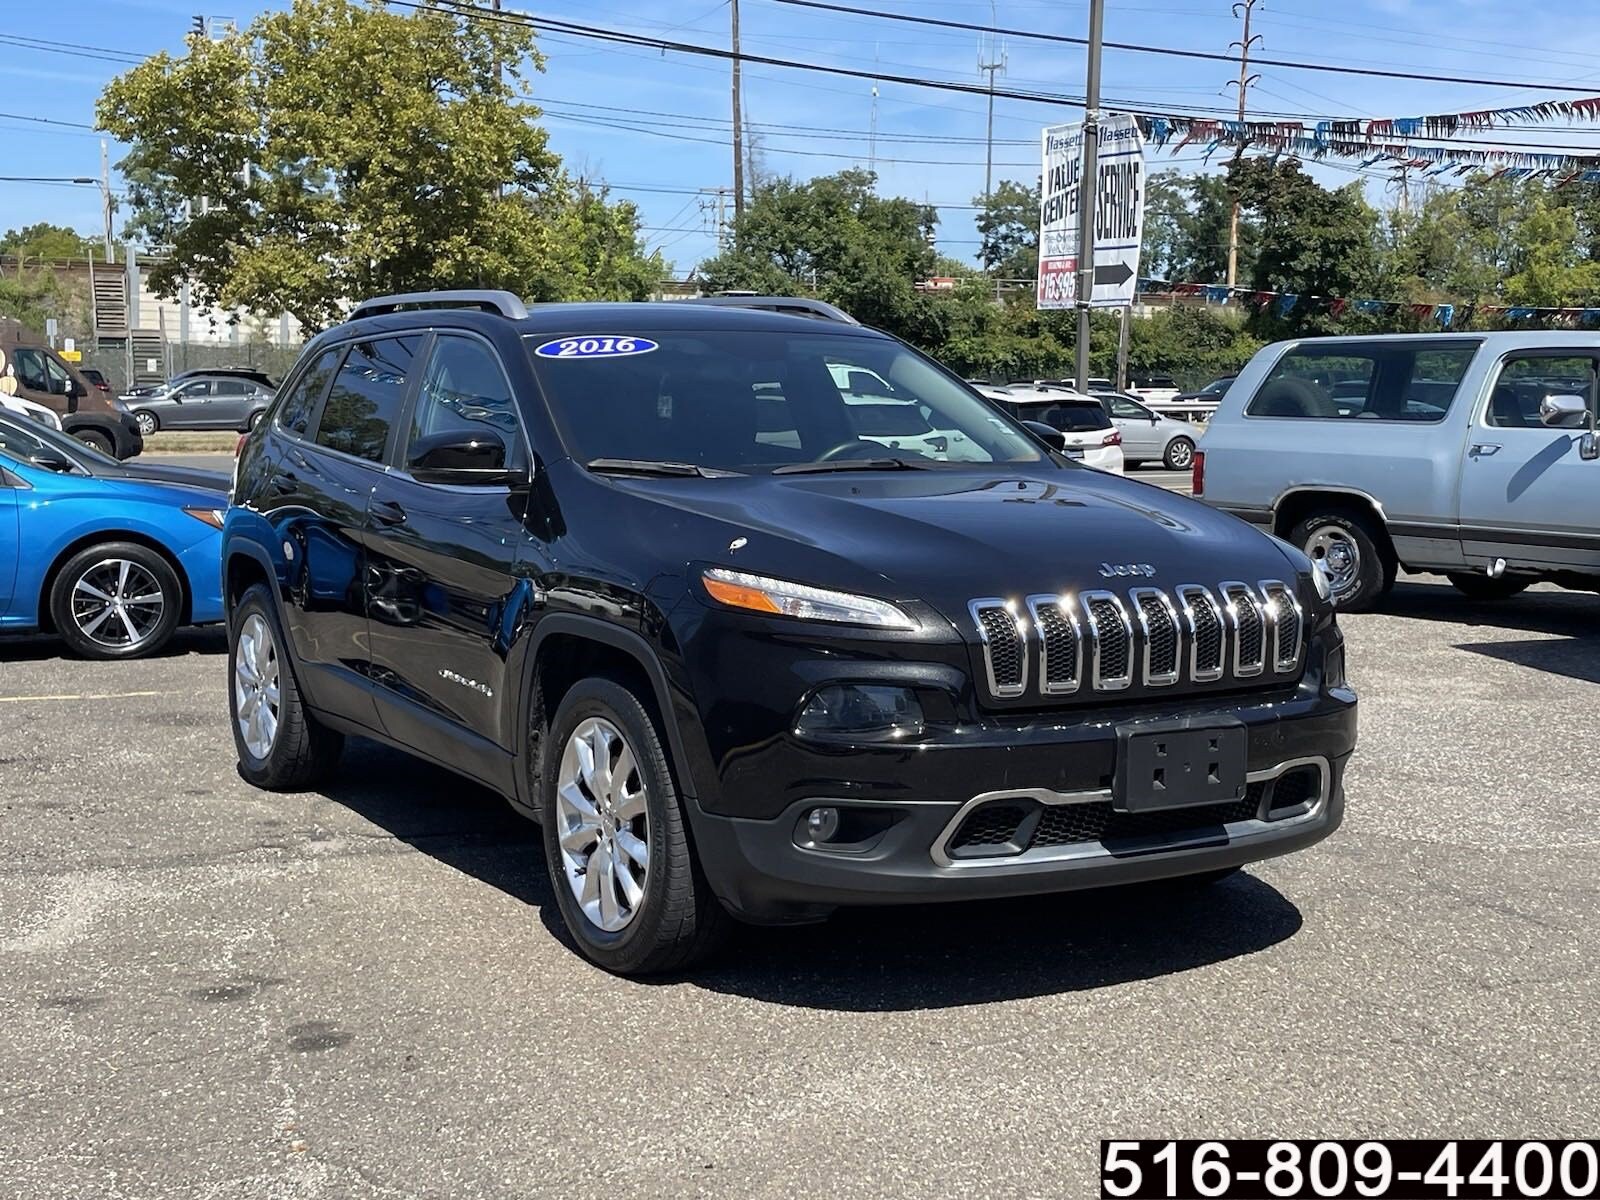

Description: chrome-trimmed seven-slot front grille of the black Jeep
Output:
[968,579,1306,699]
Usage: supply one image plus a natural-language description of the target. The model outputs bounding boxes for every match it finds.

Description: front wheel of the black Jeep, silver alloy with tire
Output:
[539,678,730,974]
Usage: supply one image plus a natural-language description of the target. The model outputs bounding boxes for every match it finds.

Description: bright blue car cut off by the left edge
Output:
[0,414,229,659]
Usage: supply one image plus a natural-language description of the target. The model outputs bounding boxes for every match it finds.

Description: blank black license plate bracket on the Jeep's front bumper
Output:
[1110,717,1250,813]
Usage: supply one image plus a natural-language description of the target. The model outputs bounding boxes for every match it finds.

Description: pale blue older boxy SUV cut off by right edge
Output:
[1195,333,1600,608]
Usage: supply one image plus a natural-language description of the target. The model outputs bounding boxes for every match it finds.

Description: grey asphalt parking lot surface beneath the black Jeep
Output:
[0,569,1600,1200]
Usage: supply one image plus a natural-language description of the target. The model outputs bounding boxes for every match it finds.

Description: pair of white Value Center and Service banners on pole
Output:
[1038,114,1144,309]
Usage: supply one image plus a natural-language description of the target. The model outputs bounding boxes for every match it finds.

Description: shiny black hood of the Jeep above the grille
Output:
[595,466,1294,627]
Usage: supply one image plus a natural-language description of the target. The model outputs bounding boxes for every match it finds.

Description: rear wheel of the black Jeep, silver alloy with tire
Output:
[227,584,344,792]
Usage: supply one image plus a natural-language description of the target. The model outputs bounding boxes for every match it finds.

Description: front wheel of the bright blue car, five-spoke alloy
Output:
[50,542,184,659]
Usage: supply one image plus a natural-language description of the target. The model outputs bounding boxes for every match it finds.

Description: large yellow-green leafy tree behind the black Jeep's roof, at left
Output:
[98,0,664,328]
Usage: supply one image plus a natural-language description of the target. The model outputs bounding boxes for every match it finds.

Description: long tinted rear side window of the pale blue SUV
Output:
[1245,341,1478,422]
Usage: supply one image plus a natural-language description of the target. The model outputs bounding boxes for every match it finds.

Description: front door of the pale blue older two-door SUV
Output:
[1461,347,1600,571]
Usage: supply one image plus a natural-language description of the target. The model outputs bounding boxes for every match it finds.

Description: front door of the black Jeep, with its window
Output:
[366,333,530,782]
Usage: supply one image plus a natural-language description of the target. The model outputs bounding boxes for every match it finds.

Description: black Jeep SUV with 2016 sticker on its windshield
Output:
[224,293,1355,973]
